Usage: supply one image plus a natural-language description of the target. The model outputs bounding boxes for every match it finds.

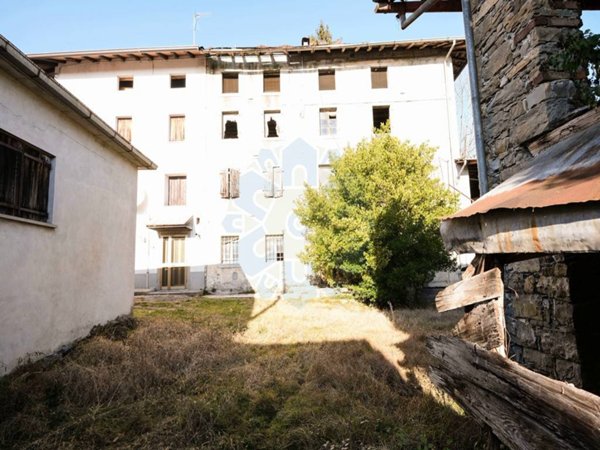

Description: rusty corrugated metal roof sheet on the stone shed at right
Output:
[446,124,600,220]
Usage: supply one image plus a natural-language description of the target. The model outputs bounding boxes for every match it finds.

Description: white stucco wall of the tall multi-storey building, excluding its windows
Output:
[56,51,468,291]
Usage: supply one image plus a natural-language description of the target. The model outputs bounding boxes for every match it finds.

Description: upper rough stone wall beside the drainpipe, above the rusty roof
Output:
[471,0,581,188]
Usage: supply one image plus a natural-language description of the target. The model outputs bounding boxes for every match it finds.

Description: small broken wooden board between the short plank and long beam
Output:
[452,300,504,350]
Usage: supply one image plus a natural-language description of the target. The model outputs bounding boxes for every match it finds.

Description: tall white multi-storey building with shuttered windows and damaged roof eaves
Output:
[33,40,470,293]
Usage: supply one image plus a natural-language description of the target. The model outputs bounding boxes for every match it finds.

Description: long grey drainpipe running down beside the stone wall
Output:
[461,0,488,195]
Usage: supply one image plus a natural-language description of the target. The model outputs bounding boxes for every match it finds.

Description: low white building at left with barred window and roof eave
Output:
[0,36,155,376]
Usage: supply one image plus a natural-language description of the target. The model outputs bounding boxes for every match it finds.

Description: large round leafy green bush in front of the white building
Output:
[296,125,457,306]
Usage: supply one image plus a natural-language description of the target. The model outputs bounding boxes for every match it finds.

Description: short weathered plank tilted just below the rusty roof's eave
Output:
[435,267,504,312]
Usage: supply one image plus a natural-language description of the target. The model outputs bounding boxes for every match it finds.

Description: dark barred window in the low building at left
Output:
[0,130,54,222]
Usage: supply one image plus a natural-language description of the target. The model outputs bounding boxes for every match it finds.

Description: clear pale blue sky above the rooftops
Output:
[0,0,600,53]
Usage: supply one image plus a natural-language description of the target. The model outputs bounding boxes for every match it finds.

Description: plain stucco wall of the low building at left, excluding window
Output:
[0,67,137,375]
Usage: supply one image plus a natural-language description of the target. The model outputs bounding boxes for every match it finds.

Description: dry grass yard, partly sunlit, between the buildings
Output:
[0,299,487,449]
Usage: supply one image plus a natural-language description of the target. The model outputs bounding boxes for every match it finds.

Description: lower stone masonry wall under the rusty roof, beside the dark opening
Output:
[504,255,582,387]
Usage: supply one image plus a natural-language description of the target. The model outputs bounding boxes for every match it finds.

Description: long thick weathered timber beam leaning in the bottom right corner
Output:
[427,336,600,450]
